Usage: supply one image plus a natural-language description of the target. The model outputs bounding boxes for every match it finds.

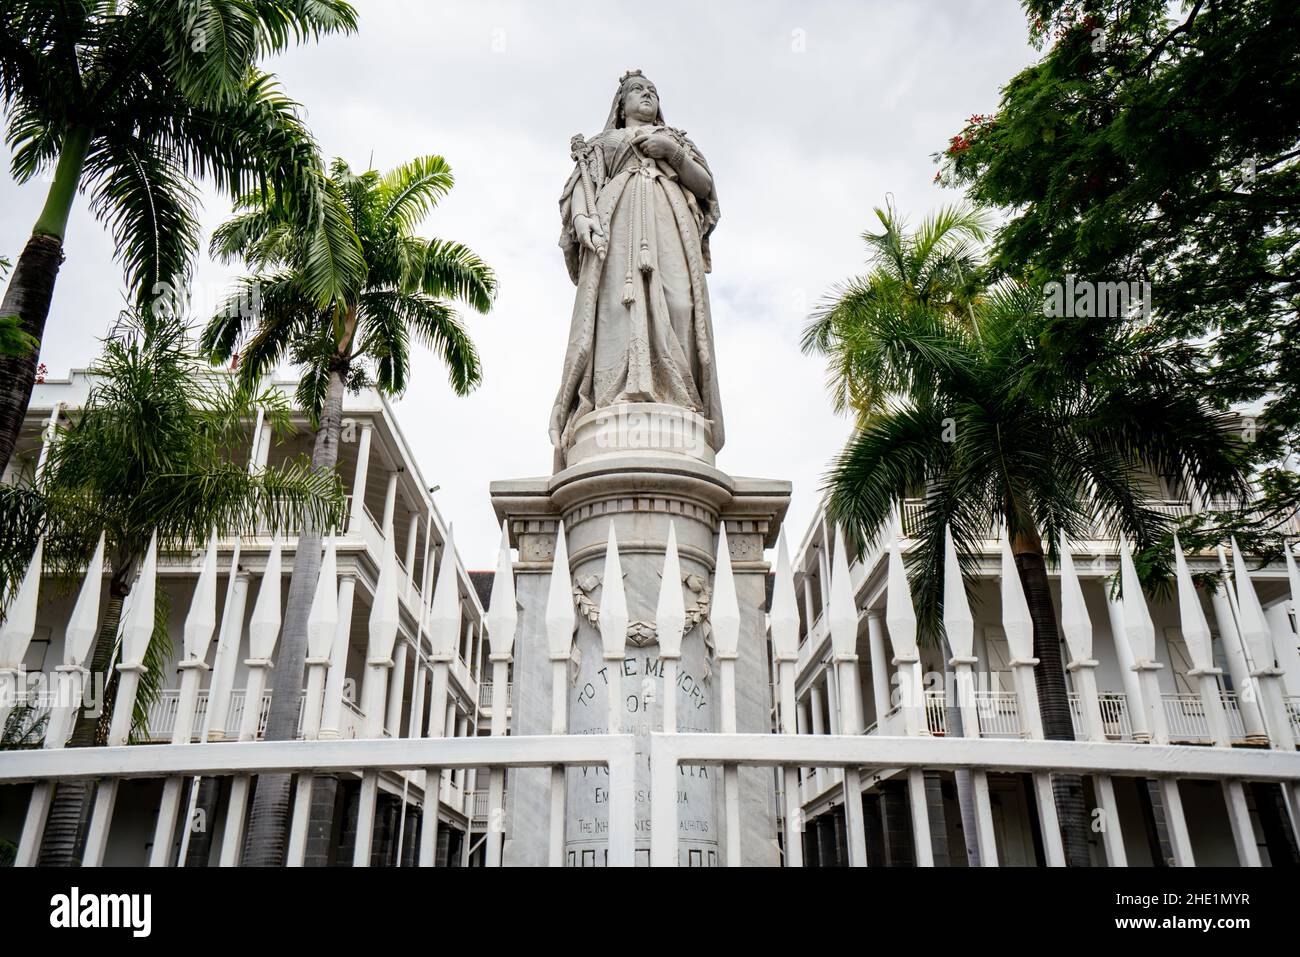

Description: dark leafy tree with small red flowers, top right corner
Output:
[935,0,1300,534]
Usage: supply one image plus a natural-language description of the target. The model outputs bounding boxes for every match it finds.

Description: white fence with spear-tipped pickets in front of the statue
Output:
[0,521,1300,866]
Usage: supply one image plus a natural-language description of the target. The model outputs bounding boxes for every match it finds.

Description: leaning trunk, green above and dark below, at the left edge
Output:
[0,129,91,471]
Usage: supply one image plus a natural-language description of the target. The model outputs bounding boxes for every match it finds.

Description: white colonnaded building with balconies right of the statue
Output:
[794,494,1300,866]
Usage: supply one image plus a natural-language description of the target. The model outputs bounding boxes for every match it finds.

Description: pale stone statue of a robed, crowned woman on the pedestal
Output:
[550,70,723,468]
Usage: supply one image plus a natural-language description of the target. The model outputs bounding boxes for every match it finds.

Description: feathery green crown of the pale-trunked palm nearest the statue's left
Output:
[203,156,497,417]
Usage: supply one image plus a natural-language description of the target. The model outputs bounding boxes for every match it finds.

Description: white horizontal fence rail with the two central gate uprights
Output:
[0,732,1300,866]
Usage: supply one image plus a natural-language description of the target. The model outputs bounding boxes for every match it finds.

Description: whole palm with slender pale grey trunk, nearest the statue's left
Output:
[203,156,497,865]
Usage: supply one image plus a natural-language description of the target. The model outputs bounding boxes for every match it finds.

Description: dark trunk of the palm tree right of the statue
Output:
[1011,531,1091,867]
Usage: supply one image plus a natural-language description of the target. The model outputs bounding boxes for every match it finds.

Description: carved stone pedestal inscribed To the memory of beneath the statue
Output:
[490,406,790,866]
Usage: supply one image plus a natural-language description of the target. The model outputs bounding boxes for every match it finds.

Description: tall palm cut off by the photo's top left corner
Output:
[0,0,356,468]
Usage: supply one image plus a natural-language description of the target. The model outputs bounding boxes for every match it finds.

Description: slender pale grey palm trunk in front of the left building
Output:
[244,371,345,867]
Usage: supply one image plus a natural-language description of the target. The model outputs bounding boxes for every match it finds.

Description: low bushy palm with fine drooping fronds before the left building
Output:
[27,310,343,866]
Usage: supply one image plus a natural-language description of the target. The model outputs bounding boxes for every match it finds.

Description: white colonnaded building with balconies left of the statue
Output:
[0,372,491,866]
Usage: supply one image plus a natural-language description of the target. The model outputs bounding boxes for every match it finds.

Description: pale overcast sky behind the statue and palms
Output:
[0,0,1034,568]
